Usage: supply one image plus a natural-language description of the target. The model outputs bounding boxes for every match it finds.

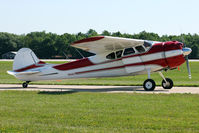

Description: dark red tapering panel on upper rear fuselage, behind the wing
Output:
[53,58,94,71]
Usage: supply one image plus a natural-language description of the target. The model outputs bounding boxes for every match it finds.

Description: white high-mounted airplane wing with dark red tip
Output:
[71,36,144,54]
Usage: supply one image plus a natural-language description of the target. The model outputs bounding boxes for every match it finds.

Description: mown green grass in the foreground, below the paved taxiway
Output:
[0,91,199,133]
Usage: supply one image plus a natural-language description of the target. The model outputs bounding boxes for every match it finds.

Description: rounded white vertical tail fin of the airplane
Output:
[13,48,39,70]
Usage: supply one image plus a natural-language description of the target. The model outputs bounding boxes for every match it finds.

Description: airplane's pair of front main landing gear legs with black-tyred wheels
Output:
[143,71,173,91]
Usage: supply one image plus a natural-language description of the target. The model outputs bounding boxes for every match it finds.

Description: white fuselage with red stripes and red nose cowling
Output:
[15,41,185,81]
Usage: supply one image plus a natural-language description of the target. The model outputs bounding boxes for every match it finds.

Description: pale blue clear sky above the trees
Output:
[0,0,199,35]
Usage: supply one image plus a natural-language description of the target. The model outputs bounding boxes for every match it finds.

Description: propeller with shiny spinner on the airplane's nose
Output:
[181,34,192,79]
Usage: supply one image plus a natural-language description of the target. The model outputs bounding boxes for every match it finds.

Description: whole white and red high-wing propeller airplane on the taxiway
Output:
[8,36,191,91]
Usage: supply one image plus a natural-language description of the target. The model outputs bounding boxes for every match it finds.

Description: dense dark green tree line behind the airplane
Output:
[0,29,199,59]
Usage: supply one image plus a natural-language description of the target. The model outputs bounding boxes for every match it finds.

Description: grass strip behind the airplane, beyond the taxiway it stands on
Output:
[0,61,199,86]
